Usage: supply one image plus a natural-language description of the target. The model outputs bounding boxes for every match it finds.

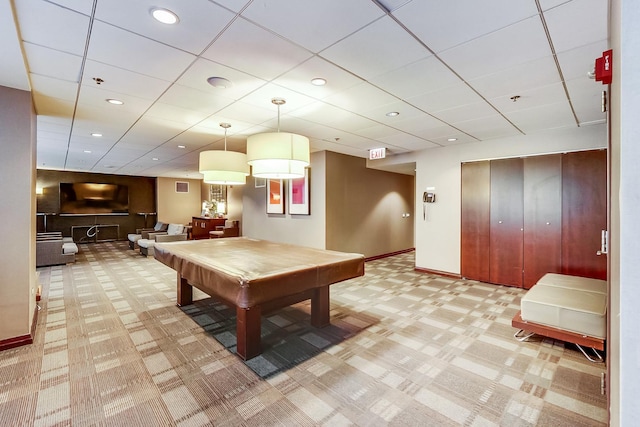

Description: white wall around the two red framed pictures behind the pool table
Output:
[242,152,326,249]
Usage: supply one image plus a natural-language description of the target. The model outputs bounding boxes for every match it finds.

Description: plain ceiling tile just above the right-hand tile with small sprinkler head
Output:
[468,56,560,99]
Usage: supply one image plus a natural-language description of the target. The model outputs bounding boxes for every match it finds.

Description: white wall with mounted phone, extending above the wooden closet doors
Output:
[415,125,607,274]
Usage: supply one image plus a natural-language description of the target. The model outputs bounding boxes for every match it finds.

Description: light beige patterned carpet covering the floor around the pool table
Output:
[0,242,607,426]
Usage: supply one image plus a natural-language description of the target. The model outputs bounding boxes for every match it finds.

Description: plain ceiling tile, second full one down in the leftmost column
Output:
[24,43,82,83]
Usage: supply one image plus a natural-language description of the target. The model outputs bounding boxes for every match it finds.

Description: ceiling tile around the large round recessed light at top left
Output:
[96,0,235,55]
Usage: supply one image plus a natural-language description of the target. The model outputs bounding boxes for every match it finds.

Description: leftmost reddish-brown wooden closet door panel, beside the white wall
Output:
[460,161,491,282]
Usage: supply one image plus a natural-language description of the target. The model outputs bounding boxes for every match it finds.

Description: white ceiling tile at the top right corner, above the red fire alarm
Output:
[544,0,609,53]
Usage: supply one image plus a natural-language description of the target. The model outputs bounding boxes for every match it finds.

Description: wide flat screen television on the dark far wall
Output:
[60,182,129,215]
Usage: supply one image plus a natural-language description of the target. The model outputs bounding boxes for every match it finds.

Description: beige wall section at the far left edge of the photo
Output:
[0,86,37,342]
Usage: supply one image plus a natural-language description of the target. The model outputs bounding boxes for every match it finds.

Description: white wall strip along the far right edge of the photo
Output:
[607,0,640,426]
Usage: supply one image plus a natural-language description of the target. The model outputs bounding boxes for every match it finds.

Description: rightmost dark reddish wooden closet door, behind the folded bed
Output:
[562,150,607,280]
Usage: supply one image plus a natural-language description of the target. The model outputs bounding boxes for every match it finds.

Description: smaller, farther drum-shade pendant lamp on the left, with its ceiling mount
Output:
[199,123,249,185]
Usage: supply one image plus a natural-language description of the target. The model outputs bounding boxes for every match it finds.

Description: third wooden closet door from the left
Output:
[523,154,562,289]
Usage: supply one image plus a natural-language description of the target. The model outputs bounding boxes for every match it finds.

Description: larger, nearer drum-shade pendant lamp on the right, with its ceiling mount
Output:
[247,98,309,179]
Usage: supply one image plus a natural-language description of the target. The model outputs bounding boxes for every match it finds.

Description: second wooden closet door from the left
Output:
[489,158,524,287]
